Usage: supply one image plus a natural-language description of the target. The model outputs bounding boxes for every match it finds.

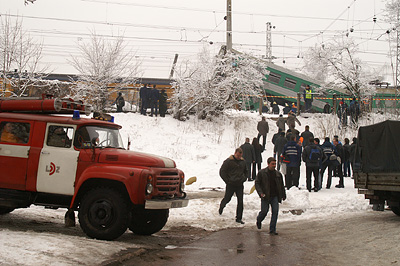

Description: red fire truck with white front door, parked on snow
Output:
[0,97,188,240]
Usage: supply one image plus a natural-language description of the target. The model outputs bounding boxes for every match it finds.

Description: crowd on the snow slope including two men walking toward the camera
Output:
[219,112,357,235]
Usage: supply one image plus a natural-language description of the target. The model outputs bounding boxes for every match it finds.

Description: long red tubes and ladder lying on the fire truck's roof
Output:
[0,95,92,115]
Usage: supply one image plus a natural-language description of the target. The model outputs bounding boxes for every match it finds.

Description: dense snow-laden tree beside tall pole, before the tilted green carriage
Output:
[172,48,264,119]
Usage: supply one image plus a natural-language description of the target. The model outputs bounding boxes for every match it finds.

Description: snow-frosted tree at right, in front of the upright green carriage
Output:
[304,37,378,98]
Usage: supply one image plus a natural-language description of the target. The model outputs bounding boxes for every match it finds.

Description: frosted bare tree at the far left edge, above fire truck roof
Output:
[0,15,48,96]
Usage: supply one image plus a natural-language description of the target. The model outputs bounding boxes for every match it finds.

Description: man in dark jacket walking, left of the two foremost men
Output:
[218,148,247,224]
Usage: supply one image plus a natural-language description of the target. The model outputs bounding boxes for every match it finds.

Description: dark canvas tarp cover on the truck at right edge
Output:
[355,120,400,173]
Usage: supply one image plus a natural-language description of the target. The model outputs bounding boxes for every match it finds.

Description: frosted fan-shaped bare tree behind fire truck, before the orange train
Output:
[70,32,140,110]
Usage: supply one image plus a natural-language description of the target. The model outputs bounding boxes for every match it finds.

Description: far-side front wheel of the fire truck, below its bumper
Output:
[129,209,169,235]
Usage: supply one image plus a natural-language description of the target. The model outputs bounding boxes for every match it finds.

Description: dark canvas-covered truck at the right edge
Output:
[353,120,400,216]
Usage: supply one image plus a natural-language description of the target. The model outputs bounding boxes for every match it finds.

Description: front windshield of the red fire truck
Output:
[74,126,124,149]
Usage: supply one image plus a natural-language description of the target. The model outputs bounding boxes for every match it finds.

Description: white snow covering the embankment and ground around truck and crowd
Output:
[0,111,383,265]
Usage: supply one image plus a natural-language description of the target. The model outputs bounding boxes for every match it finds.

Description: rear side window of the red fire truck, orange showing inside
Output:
[0,121,31,144]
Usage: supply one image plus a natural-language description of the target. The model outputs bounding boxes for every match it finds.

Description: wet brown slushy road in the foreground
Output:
[103,211,400,266]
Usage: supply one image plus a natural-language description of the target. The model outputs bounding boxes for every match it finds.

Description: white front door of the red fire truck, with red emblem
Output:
[36,124,79,195]
